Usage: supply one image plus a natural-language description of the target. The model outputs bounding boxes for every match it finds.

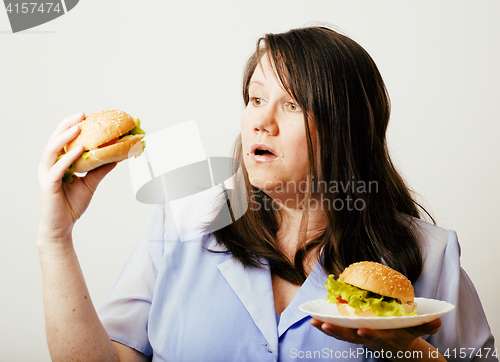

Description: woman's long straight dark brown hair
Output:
[209,27,425,284]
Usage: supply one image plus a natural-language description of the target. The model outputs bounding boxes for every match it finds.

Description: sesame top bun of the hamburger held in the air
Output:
[64,110,135,152]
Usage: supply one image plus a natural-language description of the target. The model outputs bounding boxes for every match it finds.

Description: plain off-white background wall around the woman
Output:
[0,0,500,361]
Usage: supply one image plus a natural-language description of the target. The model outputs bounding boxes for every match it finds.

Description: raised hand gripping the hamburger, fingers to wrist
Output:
[38,113,116,243]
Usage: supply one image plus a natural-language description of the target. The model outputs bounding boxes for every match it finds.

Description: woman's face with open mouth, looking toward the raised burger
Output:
[241,55,308,199]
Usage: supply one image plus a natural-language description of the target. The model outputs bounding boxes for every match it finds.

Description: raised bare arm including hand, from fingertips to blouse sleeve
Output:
[37,114,147,361]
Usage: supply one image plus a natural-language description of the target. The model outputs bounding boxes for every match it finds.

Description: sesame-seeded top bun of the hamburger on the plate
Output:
[339,261,415,303]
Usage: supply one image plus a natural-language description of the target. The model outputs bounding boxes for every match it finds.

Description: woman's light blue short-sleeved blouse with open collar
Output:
[98,201,497,362]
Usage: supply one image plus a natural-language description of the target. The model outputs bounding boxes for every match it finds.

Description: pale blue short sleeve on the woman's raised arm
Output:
[97,205,163,357]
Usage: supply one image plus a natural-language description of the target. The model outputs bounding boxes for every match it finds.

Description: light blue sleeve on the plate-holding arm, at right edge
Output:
[415,231,498,361]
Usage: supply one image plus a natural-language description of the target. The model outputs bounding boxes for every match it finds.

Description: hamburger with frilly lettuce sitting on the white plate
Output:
[325,261,417,317]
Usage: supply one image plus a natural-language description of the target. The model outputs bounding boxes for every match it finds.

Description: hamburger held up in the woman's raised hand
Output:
[64,110,146,182]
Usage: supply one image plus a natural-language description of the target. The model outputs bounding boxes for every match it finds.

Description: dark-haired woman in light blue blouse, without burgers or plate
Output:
[38,27,495,361]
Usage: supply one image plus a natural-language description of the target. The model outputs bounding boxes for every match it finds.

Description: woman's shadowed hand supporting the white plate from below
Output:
[311,318,445,361]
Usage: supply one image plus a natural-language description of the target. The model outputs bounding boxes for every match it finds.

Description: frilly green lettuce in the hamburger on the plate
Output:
[325,274,417,317]
